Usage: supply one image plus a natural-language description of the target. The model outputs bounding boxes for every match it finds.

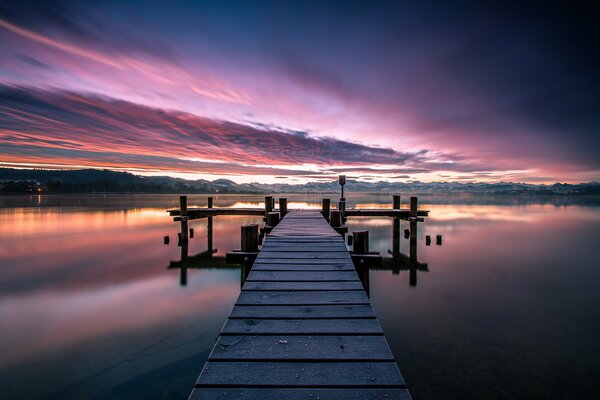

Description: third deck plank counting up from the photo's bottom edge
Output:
[208,335,394,362]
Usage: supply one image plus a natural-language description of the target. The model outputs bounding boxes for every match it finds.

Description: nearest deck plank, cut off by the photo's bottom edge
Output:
[189,387,411,400]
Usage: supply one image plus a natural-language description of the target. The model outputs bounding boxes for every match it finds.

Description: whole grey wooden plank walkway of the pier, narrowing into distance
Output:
[190,211,410,400]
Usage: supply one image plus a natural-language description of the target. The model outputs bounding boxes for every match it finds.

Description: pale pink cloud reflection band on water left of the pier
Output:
[0,272,239,367]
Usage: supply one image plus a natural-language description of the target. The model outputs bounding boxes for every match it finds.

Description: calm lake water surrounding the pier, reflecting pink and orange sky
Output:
[0,195,600,400]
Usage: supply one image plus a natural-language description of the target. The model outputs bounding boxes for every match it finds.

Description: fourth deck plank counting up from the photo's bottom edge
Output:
[221,319,383,335]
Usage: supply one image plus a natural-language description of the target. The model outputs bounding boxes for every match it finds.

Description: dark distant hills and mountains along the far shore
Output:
[0,168,600,195]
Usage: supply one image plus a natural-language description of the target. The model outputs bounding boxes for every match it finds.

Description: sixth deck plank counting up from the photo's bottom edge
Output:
[236,290,369,305]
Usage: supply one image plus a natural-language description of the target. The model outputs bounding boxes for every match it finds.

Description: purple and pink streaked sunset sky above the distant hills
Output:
[0,0,600,183]
